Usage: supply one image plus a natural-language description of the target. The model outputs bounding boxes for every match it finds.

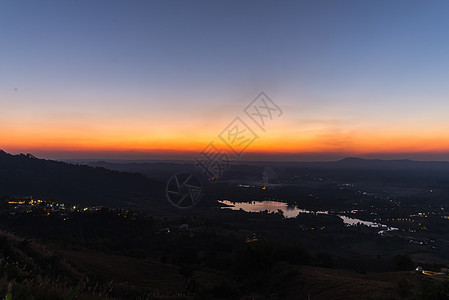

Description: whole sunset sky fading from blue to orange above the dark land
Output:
[0,0,449,160]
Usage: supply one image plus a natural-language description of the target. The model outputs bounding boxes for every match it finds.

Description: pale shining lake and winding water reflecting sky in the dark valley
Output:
[218,200,398,234]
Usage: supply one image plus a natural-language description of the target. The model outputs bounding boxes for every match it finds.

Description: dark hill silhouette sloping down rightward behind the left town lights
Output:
[0,150,164,207]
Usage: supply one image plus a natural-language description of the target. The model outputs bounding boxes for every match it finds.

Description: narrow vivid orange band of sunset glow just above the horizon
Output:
[2,127,449,158]
